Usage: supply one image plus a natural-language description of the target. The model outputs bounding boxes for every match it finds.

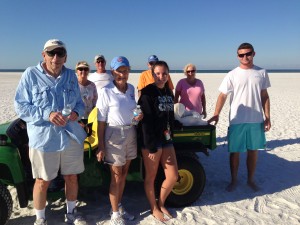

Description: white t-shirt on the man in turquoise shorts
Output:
[219,66,271,124]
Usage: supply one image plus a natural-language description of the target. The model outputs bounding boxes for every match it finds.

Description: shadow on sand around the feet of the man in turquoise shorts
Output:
[193,135,300,206]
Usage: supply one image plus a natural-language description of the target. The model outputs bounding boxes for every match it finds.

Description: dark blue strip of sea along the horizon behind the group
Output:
[0,69,300,73]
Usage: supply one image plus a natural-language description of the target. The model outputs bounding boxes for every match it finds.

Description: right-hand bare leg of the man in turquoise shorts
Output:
[247,150,259,191]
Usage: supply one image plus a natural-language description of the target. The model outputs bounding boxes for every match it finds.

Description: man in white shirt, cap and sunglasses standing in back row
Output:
[88,55,113,93]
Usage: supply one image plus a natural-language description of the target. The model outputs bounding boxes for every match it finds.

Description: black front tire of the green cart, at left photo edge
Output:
[0,183,13,225]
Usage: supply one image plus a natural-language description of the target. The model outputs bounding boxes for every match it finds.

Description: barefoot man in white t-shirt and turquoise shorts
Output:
[208,43,271,191]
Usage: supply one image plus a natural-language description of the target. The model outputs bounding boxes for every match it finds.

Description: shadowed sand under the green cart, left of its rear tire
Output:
[7,182,150,225]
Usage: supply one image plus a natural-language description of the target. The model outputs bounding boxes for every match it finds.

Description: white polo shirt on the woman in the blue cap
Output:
[96,82,136,126]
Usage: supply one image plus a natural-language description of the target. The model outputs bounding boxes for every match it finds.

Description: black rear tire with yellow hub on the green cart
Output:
[156,153,206,208]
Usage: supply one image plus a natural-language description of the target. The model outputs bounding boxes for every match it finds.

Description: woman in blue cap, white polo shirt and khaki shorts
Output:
[96,56,143,225]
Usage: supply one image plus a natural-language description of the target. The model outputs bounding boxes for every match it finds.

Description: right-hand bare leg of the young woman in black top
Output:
[158,146,178,218]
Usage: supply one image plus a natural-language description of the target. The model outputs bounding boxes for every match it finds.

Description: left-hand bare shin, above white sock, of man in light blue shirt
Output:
[32,178,51,210]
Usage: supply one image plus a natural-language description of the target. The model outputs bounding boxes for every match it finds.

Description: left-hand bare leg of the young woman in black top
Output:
[142,149,166,221]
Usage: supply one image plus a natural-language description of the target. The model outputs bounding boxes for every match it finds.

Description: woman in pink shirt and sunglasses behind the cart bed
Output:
[174,64,207,118]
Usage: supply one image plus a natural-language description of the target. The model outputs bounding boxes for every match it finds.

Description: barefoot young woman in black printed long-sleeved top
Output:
[138,61,178,221]
